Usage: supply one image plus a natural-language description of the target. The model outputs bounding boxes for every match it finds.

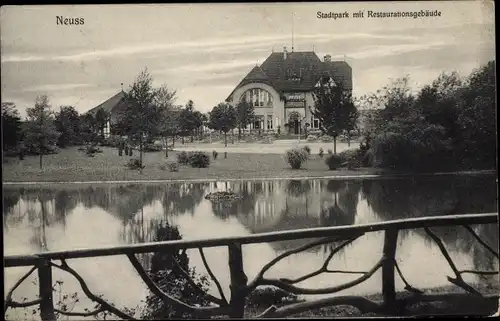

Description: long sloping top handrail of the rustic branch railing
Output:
[4,213,498,267]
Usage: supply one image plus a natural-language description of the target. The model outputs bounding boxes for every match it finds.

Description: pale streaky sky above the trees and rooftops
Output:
[0,1,495,115]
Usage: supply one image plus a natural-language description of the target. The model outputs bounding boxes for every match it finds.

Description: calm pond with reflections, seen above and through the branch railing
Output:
[3,175,498,318]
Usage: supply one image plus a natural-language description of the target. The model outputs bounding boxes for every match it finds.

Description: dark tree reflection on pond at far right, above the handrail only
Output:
[363,176,497,220]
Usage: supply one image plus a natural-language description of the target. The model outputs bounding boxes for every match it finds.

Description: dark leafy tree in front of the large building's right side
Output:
[311,79,358,154]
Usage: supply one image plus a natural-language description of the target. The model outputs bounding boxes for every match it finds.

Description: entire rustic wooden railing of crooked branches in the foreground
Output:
[4,213,499,320]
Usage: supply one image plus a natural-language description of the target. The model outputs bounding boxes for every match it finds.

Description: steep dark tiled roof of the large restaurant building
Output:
[231,51,352,100]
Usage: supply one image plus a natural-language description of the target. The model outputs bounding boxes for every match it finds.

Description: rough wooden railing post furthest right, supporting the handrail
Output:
[382,229,398,311]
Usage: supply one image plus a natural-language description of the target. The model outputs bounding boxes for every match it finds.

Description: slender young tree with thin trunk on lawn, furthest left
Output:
[24,95,59,169]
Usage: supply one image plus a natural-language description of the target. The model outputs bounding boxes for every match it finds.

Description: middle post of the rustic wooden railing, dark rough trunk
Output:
[228,243,248,319]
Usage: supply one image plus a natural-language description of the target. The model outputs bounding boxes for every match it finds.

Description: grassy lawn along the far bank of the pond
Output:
[3,147,386,182]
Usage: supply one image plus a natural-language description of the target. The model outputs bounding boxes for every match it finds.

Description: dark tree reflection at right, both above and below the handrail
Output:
[362,176,498,276]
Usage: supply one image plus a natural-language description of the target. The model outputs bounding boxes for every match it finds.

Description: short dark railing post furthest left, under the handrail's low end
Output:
[38,259,56,321]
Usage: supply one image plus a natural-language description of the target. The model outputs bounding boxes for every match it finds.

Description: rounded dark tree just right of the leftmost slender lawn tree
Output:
[55,106,82,148]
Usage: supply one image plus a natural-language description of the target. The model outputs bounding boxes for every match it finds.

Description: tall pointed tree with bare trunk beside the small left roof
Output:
[119,68,162,168]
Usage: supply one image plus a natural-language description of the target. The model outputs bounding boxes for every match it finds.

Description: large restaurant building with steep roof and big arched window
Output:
[226,47,352,134]
